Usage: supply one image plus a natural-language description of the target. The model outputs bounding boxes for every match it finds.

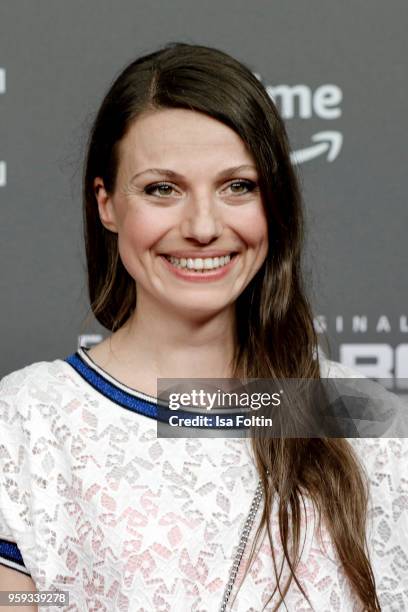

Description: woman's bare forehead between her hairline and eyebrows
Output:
[115,109,254,171]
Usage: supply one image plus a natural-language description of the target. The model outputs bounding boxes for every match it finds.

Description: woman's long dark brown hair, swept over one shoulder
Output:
[84,43,380,612]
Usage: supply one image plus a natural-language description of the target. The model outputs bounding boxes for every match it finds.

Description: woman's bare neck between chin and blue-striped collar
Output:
[101,295,235,378]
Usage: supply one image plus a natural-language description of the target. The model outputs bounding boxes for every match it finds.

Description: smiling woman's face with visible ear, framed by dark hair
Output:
[95,109,268,317]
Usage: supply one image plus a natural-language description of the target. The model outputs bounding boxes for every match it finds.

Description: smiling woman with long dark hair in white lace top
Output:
[0,44,408,612]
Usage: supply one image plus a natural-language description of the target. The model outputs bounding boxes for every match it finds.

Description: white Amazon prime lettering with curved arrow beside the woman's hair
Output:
[254,73,343,164]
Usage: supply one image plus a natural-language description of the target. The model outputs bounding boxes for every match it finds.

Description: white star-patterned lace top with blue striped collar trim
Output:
[0,350,408,612]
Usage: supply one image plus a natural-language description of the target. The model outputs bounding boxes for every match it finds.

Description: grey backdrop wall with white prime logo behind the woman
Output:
[0,0,408,393]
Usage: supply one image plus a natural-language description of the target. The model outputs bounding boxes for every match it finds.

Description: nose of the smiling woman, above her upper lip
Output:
[181,195,223,244]
